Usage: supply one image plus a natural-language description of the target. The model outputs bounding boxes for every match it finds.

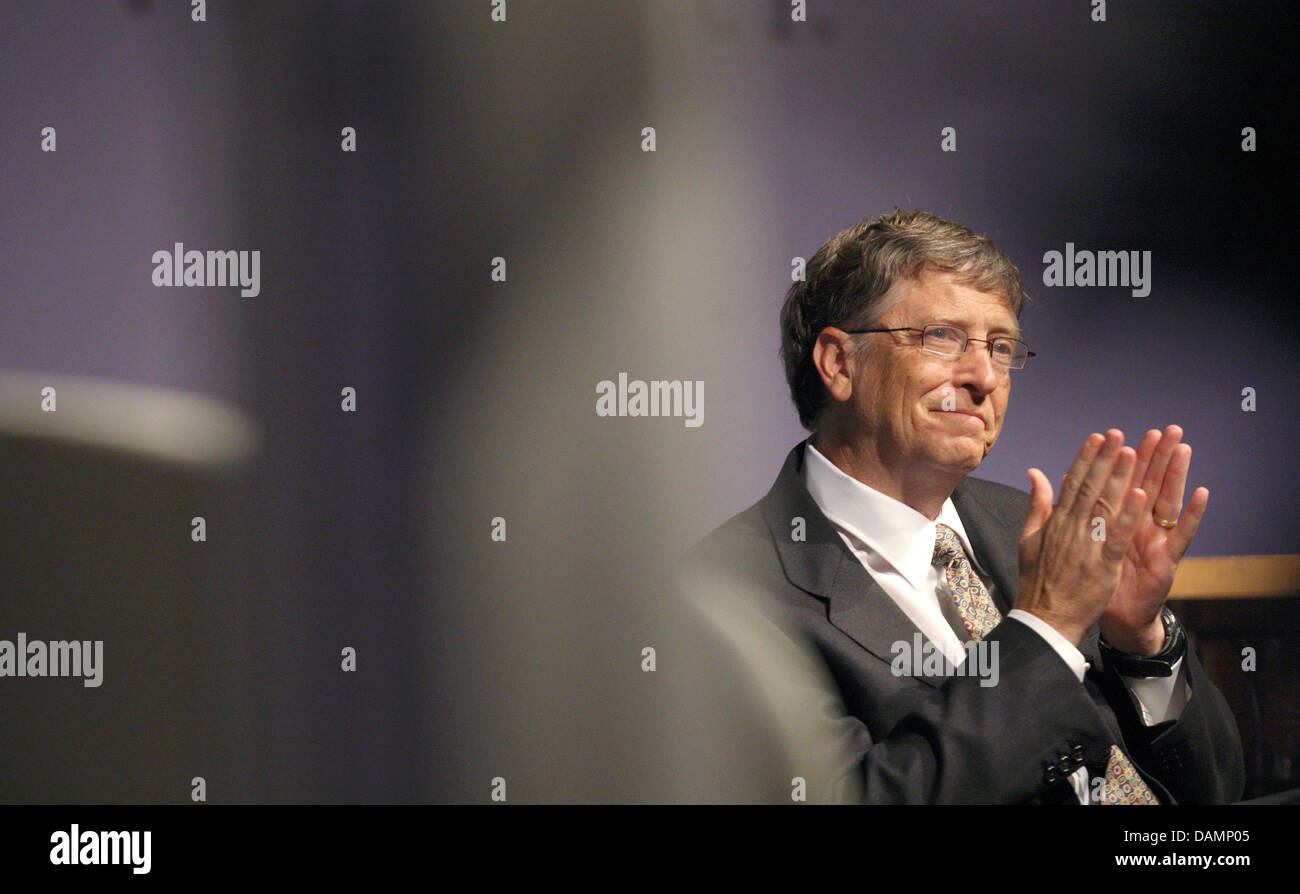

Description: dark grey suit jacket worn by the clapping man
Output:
[692,443,1244,803]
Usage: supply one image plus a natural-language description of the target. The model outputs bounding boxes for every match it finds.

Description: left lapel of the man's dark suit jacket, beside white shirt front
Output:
[763,442,946,689]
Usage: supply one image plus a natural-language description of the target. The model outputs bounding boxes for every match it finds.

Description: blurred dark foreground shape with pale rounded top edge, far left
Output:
[0,372,260,803]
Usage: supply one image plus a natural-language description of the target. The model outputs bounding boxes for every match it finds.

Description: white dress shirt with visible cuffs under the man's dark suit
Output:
[803,441,1191,804]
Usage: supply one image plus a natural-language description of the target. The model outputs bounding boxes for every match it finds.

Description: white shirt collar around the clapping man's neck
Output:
[803,441,979,590]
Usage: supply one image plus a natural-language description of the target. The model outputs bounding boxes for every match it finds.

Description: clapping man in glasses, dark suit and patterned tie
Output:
[694,211,1243,804]
